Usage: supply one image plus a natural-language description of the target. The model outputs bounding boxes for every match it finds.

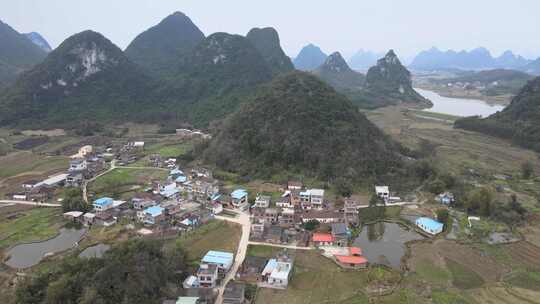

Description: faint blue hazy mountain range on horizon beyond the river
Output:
[409,47,531,71]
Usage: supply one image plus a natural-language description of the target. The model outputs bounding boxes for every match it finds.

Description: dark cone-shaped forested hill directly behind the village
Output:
[204,72,403,182]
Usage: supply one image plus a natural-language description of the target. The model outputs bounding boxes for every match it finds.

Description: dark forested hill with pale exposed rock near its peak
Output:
[0,31,156,127]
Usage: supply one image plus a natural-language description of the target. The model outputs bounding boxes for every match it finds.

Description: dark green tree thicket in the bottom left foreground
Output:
[16,239,185,304]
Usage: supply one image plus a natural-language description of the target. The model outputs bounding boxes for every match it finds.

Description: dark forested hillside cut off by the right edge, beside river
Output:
[455,77,540,151]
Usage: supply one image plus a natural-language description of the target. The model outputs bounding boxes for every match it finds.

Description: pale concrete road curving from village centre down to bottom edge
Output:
[215,210,251,304]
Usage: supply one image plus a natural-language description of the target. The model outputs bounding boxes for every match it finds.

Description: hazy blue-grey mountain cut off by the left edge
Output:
[0,21,47,88]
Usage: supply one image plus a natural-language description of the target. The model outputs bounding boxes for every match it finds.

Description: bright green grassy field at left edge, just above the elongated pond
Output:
[0,208,64,248]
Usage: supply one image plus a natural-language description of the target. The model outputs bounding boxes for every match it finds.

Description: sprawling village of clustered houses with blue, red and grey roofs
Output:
[0,135,453,304]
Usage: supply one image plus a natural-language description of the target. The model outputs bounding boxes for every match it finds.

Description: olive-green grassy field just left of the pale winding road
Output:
[177,221,242,262]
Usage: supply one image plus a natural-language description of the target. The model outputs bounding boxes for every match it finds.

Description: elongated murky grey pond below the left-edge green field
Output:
[5,228,86,269]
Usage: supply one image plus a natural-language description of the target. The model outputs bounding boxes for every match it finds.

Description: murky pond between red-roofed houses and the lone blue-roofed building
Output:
[354,222,424,269]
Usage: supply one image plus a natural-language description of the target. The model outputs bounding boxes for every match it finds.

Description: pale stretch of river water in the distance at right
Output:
[415,88,504,117]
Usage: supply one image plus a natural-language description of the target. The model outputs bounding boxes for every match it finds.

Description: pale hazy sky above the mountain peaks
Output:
[0,0,540,58]
